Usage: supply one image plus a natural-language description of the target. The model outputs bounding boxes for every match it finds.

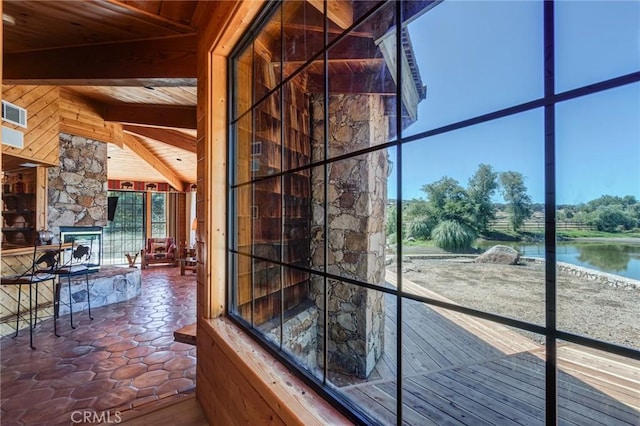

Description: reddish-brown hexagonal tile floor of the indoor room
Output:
[0,266,196,426]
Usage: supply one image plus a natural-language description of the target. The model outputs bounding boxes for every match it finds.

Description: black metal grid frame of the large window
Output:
[227,1,640,424]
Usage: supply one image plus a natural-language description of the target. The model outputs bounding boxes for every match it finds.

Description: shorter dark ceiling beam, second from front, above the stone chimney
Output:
[104,104,197,129]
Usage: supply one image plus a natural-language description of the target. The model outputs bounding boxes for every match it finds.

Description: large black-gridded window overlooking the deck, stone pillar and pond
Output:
[228,0,640,425]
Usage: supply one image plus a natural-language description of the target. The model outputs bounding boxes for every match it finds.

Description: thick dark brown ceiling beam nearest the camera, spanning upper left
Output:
[3,35,198,86]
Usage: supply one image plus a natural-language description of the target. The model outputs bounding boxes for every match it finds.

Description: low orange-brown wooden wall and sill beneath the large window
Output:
[196,319,352,426]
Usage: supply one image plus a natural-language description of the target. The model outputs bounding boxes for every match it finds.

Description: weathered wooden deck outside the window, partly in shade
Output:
[338,274,640,426]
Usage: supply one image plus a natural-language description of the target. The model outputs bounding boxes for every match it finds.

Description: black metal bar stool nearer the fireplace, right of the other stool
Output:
[52,236,93,336]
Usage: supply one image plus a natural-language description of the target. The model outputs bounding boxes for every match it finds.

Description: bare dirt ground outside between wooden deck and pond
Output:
[387,257,640,349]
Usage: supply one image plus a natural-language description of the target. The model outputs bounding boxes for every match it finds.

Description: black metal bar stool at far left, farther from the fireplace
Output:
[0,239,60,349]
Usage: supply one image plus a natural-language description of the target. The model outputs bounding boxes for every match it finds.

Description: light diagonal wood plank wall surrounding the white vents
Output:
[2,84,60,166]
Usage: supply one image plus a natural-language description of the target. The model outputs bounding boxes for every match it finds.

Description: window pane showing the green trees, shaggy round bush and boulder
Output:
[400,110,545,324]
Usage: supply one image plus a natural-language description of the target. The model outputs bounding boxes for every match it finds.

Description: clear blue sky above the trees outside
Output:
[389,1,640,204]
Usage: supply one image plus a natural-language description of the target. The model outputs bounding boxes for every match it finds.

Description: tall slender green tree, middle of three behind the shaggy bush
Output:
[467,164,498,232]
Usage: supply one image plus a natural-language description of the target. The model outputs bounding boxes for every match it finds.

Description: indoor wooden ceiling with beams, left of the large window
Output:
[3,0,205,189]
